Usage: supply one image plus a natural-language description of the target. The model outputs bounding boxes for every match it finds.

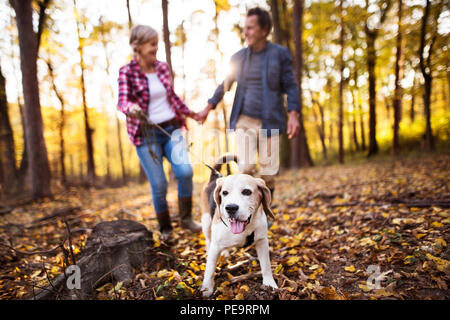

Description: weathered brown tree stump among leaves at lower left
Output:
[33,220,154,300]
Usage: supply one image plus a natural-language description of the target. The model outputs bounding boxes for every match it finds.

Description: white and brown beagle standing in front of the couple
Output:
[201,155,278,297]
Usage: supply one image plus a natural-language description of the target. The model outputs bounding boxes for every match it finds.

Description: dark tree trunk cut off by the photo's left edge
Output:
[0,61,18,194]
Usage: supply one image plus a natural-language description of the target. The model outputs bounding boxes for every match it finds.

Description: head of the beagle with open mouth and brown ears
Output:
[214,174,273,234]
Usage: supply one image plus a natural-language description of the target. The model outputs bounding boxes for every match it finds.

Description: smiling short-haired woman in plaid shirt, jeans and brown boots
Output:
[118,25,201,240]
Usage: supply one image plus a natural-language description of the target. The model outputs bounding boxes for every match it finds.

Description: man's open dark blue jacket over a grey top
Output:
[208,41,300,136]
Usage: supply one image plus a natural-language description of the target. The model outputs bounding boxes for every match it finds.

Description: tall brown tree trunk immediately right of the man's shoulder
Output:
[291,0,313,167]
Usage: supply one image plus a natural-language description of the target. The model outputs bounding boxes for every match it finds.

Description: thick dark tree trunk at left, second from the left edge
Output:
[11,0,51,199]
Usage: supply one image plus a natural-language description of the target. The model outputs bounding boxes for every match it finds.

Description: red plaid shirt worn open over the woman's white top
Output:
[117,58,191,146]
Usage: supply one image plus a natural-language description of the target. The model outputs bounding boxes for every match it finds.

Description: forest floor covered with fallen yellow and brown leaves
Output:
[0,155,450,299]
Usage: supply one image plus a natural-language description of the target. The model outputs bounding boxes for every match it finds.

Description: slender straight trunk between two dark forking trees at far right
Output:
[392,0,403,155]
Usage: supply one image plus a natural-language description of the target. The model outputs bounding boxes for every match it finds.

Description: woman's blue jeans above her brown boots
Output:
[136,126,193,214]
